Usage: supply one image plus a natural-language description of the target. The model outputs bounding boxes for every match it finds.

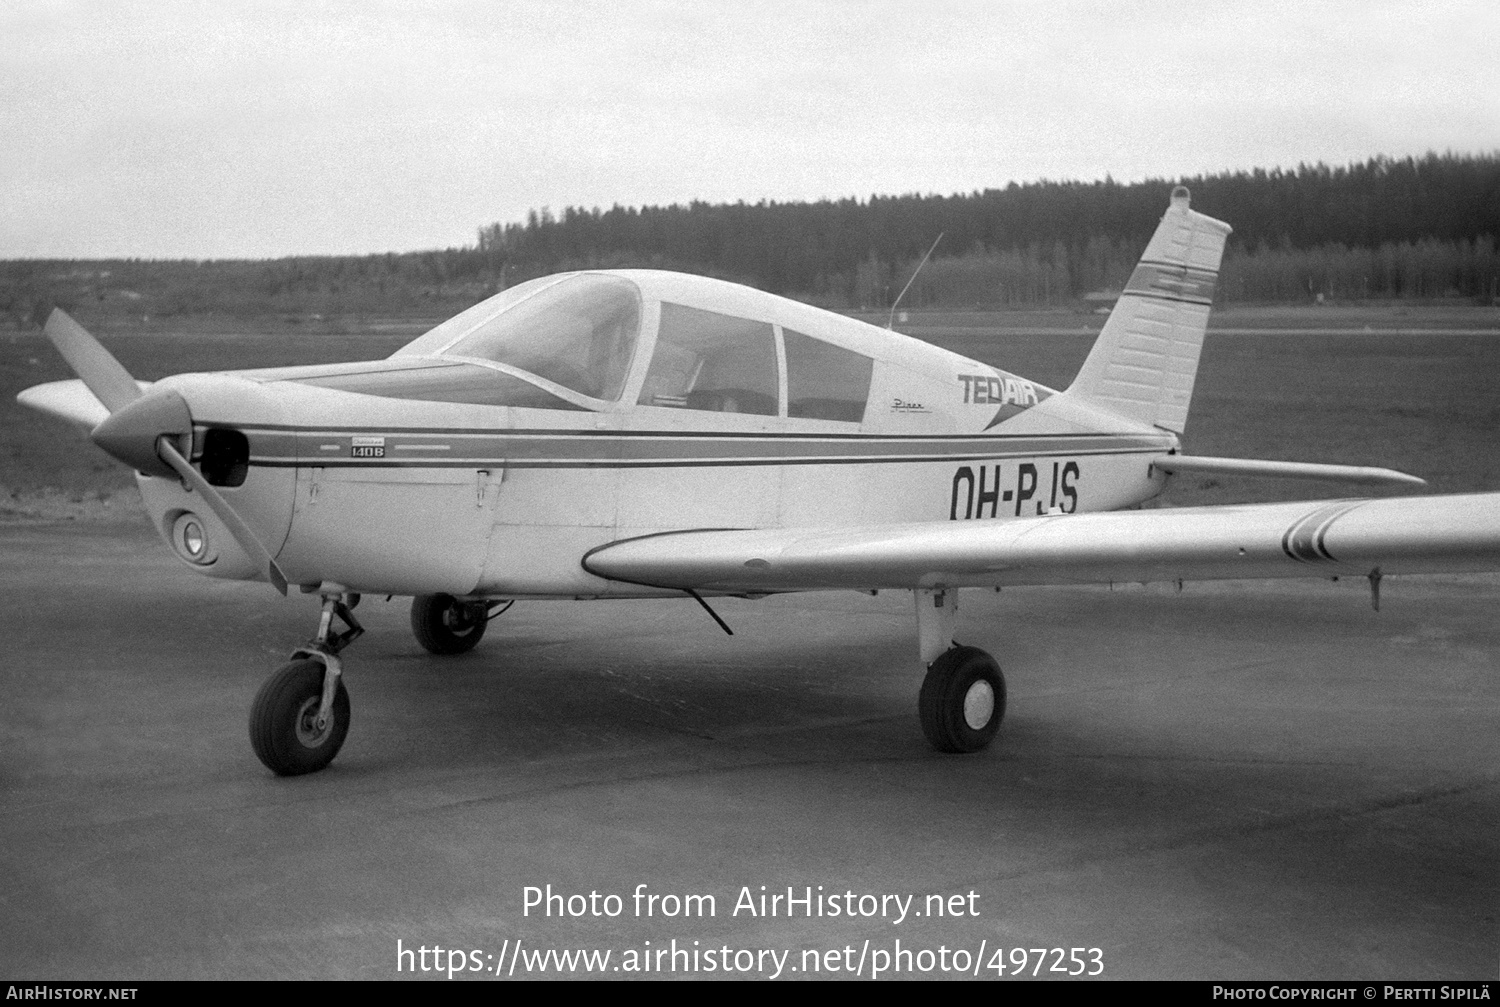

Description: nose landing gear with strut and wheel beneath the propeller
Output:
[251,591,365,776]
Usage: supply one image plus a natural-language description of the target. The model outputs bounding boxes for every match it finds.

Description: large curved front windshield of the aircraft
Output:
[443,273,641,401]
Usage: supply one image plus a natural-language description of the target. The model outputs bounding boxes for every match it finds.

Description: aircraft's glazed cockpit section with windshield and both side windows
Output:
[327,273,875,423]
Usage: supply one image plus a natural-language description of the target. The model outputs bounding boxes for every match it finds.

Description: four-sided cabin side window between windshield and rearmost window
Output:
[639,303,777,416]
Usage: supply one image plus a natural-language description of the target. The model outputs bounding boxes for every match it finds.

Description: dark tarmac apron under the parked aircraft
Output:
[0,522,1500,980]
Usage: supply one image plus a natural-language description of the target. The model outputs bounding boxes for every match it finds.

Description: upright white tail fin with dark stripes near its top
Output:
[1068,186,1230,434]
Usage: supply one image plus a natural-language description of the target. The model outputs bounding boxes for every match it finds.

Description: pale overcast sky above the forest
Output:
[0,0,1500,258]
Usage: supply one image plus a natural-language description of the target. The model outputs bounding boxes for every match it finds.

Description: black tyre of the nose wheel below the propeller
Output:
[251,659,350,776]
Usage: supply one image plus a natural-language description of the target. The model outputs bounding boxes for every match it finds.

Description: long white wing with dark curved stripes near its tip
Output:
[584,494,1500,594]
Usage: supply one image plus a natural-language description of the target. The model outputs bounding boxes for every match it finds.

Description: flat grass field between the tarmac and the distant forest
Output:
[0,306,1500,519]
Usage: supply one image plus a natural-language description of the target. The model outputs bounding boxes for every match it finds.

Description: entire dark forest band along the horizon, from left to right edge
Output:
[0,152,1500,326]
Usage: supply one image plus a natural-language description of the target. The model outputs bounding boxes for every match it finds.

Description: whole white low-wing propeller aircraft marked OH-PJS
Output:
[20,188,1500,774]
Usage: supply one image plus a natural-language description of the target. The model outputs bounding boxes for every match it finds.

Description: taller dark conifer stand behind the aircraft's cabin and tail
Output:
[479,153,1500,306]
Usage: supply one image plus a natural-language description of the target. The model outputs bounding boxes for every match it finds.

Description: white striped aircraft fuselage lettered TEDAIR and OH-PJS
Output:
[138,270,1178,597]
